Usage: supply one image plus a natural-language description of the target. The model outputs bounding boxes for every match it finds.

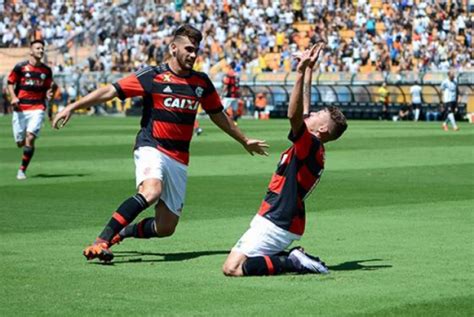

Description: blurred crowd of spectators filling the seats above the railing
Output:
[0,0,474,73]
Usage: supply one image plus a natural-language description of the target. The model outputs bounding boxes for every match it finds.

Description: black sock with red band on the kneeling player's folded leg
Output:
[242,255,296,276]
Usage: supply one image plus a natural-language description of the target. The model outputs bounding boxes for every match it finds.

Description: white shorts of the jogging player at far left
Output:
[12,110,45,142]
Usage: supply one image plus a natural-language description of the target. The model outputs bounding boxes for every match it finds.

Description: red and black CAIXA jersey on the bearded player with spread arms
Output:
[113,64,223,164]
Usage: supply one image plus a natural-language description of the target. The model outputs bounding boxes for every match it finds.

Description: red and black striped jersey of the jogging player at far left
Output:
[8,61,53,111]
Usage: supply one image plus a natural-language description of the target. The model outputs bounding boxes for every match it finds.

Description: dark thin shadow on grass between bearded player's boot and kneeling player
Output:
[92,250,229,265]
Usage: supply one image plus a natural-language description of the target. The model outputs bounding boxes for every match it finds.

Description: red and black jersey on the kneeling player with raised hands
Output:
[258,124,324,235]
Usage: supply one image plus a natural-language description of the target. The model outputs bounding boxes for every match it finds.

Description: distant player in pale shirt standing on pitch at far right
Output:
[441,71,459,131]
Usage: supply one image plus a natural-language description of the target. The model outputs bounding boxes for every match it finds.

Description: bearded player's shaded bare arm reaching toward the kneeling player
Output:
[209,112,268,155]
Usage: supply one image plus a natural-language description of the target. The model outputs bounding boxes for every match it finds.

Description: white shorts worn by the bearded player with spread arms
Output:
[133,146,188,217]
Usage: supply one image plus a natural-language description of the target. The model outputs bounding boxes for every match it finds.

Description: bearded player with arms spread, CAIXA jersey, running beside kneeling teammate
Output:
[53,25,268,262]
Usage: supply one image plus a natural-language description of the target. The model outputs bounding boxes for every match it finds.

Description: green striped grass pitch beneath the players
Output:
[0,116,474,317]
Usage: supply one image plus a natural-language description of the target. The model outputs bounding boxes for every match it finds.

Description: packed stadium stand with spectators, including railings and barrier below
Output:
[0,0,474,118]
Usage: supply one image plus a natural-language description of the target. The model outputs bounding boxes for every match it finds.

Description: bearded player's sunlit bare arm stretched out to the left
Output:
[53,85,117,129]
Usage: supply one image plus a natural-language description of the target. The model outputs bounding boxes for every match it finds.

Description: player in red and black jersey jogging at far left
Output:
[8,40,56,180]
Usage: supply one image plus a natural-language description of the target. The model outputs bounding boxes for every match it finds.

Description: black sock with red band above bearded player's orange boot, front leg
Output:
[99,194,148,242]
